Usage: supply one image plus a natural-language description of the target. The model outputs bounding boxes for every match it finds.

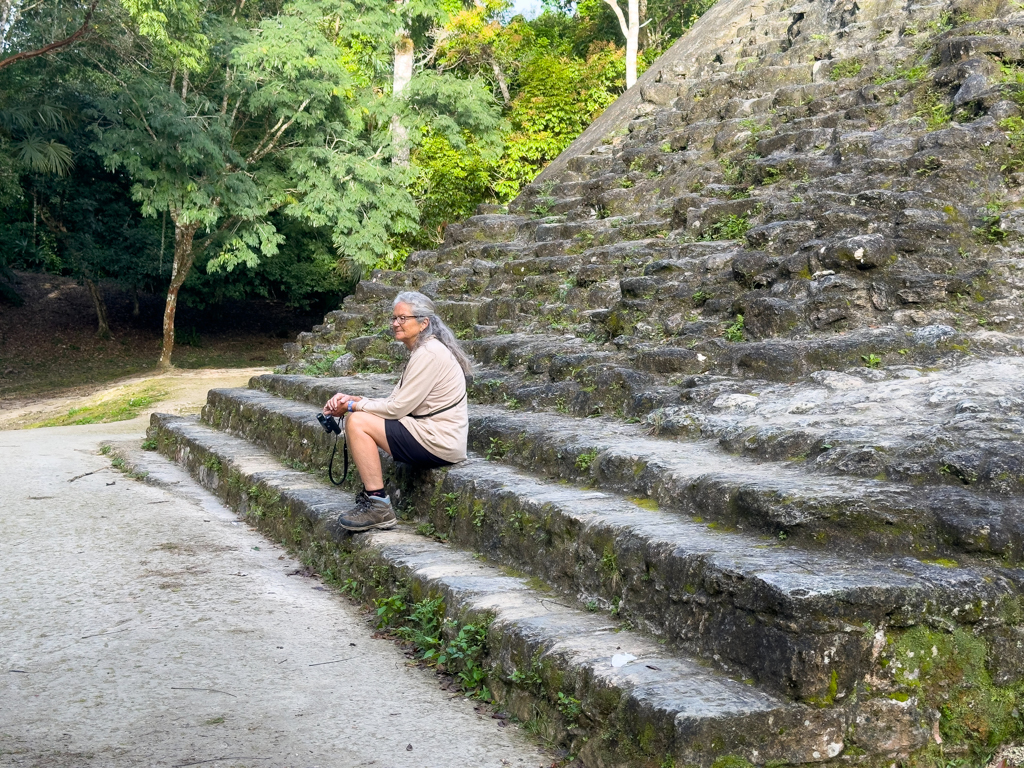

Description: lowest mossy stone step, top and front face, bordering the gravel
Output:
[146,415,856,766]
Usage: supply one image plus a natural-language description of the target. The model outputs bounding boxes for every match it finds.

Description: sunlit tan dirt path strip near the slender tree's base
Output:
[0,368,270,430]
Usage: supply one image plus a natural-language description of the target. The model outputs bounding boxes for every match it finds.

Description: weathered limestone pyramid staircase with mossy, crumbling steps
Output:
[140,0,1024,768]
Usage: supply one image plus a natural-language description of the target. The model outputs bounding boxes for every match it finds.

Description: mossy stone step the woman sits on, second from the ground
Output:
[195,380,1017,703]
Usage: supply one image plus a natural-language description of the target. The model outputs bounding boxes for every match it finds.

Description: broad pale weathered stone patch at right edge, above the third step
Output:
[647,354,1024,496]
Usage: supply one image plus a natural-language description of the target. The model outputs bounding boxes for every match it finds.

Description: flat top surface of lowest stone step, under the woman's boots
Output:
[153,414,842,762]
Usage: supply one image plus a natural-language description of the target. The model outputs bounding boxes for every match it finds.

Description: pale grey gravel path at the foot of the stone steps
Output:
[0,420,551,768]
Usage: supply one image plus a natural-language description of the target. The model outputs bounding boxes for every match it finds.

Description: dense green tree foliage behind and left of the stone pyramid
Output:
[0,0,712,335]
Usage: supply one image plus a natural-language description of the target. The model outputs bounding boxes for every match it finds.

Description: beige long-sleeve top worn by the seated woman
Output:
[357,339,469,464]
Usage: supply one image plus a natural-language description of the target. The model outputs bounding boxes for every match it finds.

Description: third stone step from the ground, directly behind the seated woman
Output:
[251,375,1024,565]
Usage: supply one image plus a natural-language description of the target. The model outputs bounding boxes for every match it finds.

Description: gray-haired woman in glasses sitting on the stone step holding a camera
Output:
[324,291,471,530]
